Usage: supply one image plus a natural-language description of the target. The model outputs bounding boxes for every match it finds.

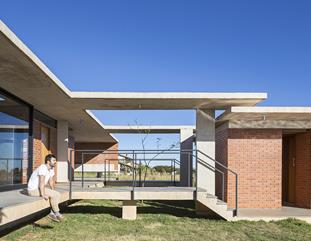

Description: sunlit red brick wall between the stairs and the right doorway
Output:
[216,127,282,208]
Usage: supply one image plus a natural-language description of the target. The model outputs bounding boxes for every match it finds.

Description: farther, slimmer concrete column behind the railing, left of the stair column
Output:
[180,128,193,187]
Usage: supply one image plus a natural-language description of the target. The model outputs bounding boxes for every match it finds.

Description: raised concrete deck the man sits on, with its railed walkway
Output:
[0,182,200,230]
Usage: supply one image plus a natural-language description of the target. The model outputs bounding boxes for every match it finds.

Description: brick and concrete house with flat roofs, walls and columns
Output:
[0,22,311,213]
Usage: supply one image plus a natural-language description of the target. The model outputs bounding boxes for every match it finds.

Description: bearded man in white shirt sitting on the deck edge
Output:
[27,154,63,222]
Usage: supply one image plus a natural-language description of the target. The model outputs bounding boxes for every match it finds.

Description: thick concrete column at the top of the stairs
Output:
[196,109,215,195]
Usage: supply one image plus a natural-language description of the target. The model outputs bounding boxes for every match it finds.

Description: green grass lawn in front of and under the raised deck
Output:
[3,201,311,241]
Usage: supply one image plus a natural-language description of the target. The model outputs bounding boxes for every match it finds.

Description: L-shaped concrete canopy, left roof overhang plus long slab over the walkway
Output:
[0,21,267,142]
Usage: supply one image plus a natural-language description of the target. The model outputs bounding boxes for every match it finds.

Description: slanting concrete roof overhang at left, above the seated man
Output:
[0,21,116,142]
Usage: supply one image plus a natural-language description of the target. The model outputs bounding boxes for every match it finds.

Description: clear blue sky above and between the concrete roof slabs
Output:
[0,0,311,149]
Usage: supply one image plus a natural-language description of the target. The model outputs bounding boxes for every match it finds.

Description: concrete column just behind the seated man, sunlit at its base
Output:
[56,121,69,182]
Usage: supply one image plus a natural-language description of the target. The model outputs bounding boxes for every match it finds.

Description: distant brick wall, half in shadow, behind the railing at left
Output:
[74,142,119,170]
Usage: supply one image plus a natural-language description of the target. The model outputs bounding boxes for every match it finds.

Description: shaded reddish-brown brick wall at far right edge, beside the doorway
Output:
[295,131,311,208]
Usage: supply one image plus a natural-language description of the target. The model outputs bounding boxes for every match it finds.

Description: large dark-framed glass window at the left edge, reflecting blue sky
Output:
[0,91,30,188]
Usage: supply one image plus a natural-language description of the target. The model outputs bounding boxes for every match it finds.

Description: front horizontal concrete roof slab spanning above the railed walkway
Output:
[71,92,267,110]
